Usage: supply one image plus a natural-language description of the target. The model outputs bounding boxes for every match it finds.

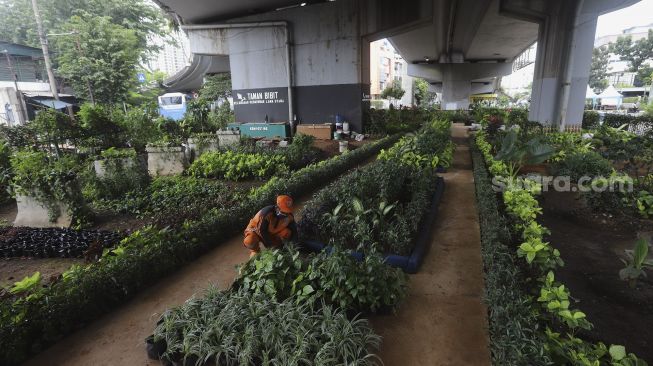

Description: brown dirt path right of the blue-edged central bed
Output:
[371,125,490,366]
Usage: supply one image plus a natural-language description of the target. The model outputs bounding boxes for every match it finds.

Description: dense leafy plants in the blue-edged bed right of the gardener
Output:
[299,160,437,255]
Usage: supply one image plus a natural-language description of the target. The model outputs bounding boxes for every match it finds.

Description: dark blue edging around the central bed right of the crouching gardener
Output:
[301,177,444,273]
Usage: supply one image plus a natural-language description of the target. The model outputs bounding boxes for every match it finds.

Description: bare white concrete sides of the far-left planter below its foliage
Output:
[14,195,72,227]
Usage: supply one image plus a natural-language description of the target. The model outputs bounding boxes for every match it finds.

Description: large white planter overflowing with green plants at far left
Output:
[11,151,89,227]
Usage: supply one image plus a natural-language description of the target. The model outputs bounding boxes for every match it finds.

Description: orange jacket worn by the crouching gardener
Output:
[245,205,297,247]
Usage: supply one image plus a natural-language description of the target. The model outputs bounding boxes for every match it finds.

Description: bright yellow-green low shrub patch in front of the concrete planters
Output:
[188,151,288,181]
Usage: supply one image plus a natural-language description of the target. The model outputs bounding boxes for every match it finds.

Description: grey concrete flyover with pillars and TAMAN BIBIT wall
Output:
[155,0,639,131]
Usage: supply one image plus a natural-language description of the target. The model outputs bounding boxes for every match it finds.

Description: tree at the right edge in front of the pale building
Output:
[610,29,653,86]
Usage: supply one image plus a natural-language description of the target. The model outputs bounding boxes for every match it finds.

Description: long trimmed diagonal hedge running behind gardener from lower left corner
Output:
[0,135,399,365]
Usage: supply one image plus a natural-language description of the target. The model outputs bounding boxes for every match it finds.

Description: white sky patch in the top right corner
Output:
[596,0,653,38]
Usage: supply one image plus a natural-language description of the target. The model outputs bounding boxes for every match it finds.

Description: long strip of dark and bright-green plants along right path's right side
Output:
[475,132,646,366]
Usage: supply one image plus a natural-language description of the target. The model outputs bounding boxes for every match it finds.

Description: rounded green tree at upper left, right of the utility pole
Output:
[57,12,143,104]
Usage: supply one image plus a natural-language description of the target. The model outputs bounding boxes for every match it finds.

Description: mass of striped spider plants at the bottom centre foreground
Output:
[154,289,381,366]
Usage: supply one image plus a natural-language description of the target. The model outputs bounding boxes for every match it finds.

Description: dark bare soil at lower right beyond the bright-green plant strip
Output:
[543,192,653,363]
